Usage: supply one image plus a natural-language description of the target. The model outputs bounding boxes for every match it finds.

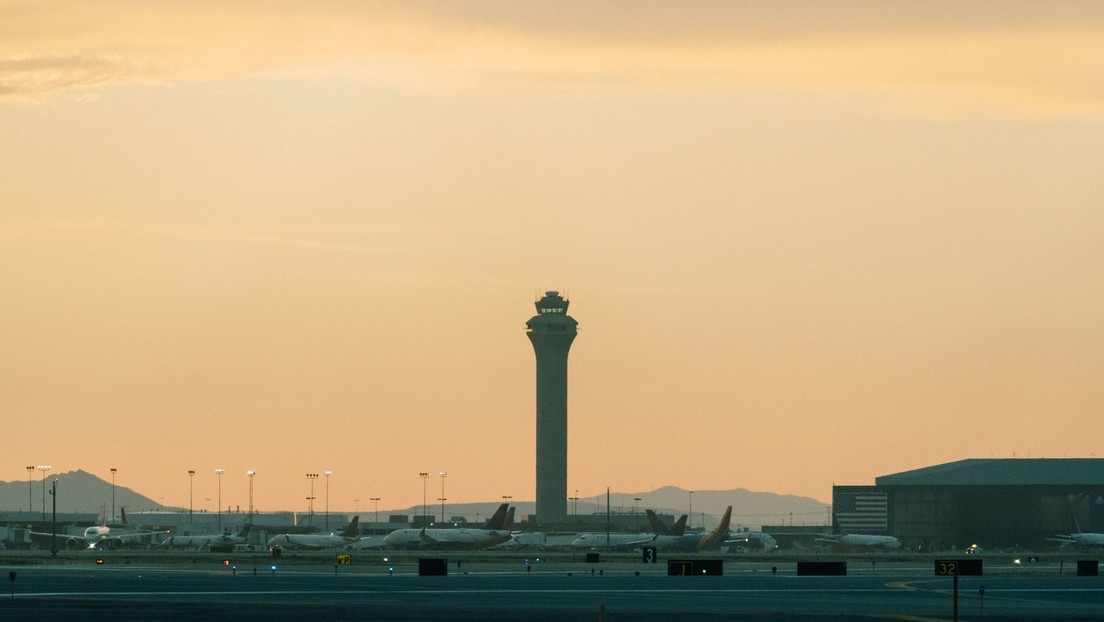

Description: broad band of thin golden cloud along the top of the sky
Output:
[0,1,1104,116]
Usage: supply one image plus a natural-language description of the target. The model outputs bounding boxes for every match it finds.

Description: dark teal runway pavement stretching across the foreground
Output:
[0,558,1104,622]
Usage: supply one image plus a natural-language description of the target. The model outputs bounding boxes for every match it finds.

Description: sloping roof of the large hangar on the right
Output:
[874,457,1104,486]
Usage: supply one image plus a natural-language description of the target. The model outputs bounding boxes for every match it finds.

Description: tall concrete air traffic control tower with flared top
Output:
[526,292,578,525]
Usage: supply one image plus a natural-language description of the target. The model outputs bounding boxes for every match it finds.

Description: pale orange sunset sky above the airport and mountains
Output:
[0,0,1104,517]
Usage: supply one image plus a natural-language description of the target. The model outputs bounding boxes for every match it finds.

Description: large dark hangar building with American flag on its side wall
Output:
[832,458,1104,550]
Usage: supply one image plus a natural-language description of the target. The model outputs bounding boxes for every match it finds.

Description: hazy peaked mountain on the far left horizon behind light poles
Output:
[0,471,165,516]
